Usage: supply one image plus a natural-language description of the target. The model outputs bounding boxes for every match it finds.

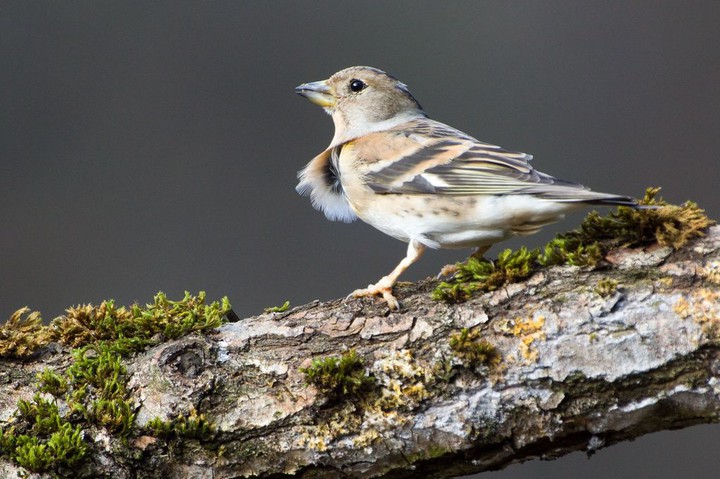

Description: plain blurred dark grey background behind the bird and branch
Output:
[0,0,720,478]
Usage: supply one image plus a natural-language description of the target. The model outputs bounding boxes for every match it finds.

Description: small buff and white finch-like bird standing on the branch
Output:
[295,66,637,309]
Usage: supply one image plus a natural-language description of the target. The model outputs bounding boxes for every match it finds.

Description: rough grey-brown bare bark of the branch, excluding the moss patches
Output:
[0,227,720,479]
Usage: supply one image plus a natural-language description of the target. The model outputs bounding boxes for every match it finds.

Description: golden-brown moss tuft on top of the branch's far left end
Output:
[0,307,53,359]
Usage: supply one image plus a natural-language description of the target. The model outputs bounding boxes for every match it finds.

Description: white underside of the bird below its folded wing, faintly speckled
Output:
[351,194,579,248]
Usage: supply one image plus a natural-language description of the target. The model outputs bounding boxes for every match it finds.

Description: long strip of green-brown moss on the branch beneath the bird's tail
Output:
[433,188,715,302]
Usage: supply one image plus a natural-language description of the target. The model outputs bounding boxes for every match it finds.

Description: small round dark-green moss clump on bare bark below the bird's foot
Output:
[300,349,375,399]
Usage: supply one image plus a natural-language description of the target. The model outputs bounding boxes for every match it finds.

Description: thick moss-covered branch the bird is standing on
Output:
[0,189,720,479]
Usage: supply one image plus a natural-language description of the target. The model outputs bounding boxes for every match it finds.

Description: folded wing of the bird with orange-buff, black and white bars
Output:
[360,118,595,201]
